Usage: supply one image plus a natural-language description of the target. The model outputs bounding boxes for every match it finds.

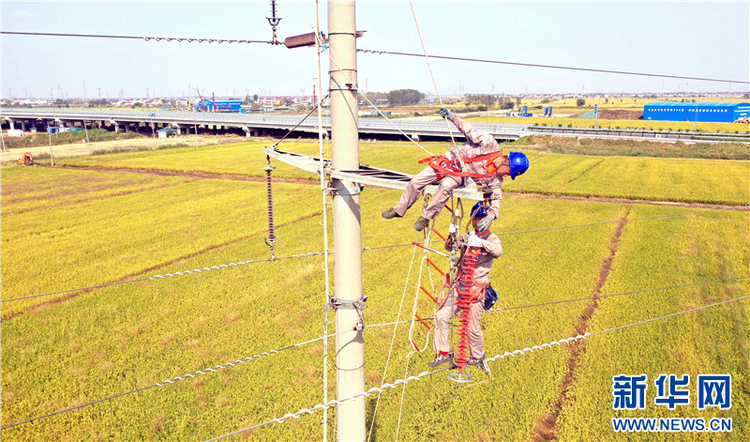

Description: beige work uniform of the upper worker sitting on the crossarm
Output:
[393,116,503,219]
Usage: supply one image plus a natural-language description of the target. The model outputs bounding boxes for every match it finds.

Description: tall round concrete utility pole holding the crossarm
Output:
[328,0,367,442]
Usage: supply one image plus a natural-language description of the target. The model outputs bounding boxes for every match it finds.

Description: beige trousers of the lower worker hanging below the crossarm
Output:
[434,290,484,359]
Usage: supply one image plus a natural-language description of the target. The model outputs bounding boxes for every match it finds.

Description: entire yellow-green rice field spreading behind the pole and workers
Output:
[0,136,750,441]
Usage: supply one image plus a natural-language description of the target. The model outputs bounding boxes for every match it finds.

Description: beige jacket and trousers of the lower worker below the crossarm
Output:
[434,232,503,359]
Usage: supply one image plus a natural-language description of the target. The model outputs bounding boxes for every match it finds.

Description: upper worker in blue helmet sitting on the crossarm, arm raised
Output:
[383,107,529,231]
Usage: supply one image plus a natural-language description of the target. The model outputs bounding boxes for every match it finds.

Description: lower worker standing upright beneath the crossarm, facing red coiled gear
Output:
[428,201,503,375]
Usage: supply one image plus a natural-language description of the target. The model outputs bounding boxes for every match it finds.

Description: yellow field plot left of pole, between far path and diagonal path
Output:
[2,168,319,317]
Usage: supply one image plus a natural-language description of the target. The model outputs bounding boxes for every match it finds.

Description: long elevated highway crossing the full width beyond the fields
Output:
[0,108,750,143]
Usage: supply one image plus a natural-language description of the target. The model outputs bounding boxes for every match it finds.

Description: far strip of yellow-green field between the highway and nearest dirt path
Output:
[53,142,750,205]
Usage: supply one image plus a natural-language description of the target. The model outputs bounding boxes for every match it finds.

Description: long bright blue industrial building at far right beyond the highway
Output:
[643,103,750,123]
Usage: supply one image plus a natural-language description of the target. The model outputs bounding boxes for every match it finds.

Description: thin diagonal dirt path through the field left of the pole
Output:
[3,211,323,321]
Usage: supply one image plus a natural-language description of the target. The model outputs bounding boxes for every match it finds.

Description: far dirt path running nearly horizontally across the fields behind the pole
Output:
[45,163,750,212]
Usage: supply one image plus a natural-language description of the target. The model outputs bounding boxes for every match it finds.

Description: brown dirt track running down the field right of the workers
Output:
[533,206,631,442]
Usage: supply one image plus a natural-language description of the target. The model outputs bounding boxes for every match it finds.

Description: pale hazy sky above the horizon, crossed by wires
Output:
[1,0,750,98]
